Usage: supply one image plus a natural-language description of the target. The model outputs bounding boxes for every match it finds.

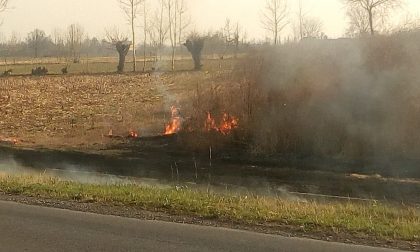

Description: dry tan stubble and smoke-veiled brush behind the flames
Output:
[4,33,420,167]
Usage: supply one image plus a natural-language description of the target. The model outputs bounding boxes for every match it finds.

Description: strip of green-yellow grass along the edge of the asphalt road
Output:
[0,175,420,242]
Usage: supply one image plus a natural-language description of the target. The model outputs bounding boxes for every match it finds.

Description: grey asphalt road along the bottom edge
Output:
[0,201,402,252]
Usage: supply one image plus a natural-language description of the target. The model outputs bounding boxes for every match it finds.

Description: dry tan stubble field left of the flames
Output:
[0,71,214,148]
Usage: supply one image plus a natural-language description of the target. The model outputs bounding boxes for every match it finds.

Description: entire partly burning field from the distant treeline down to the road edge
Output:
[0,41,420,250]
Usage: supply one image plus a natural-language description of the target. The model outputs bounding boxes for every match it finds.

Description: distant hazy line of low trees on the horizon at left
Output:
[0,24,254,62]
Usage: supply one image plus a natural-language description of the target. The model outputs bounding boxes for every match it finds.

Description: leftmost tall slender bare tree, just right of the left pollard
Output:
[118,0,143,72]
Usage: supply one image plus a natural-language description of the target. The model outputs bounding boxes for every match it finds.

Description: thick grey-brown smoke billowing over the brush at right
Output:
[235,33,420,172]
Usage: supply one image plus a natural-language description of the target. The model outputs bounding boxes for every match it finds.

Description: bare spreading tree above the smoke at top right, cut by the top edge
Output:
[343,0,403,35]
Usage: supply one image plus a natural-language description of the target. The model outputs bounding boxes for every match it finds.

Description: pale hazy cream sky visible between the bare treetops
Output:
[0,0,420,38]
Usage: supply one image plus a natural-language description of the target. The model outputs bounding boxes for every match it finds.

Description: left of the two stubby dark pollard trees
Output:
[106,29,132,73]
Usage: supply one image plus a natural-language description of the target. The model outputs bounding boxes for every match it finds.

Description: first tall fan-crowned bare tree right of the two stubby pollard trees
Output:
[261,0,289,45]
